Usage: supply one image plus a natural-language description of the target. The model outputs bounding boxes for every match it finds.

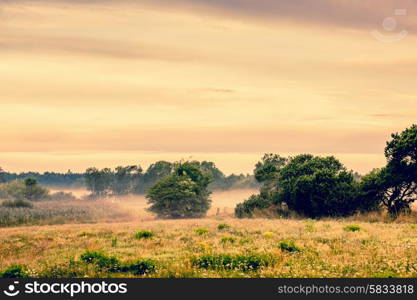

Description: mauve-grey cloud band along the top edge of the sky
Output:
[4,0,417,33]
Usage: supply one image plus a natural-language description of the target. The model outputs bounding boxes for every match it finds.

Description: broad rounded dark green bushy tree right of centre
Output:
[235,154,359,218]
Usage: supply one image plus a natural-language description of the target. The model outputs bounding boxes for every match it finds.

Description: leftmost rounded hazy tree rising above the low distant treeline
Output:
[84,168,112,196]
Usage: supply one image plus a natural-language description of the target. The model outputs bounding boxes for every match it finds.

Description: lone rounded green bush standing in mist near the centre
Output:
[146,162,211,218]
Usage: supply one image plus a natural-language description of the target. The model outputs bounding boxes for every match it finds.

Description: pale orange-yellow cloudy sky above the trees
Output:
[0,0,417,174]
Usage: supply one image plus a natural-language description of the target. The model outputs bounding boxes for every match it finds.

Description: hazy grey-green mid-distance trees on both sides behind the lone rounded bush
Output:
[84,161,259,196]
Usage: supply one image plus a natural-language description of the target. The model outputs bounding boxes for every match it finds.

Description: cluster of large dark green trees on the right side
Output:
[235,125,417,218]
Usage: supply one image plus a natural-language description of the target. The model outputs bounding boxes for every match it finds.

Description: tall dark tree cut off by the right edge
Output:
[361,125,417,218]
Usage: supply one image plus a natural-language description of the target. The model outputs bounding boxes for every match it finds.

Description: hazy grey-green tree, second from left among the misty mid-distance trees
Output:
[111,166,142,195]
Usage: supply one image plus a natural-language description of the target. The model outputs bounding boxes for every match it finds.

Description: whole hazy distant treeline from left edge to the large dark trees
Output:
[0,161,259,195]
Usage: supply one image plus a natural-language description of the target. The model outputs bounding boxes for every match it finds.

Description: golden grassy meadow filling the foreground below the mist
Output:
[0,217,417,277]
